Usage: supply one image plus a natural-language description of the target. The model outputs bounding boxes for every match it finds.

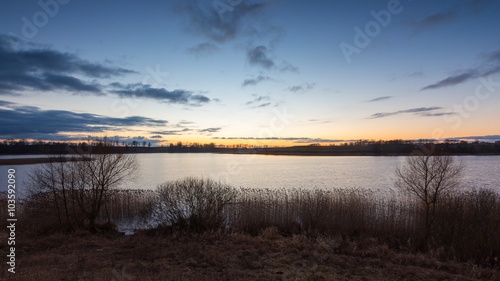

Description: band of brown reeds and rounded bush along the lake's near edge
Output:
[17,178,500,267]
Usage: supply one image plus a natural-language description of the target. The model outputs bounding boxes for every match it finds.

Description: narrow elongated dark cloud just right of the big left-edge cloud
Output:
[110,83,210,105]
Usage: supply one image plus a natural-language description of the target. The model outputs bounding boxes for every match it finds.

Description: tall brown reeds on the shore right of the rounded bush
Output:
[228,186,500,267]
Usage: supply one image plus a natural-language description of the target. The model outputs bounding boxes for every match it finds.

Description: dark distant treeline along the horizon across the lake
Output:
[0,140,500,156]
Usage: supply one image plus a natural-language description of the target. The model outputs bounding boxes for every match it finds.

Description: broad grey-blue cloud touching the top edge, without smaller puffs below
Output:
[177,0,268,43]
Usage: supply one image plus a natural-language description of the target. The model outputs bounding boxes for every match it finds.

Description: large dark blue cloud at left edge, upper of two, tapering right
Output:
[0,35,136,94]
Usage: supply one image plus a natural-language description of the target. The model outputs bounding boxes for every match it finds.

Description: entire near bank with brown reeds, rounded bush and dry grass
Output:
[0,179,500,280]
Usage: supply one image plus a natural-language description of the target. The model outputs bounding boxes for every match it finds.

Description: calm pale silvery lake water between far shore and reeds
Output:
[0,154,500,196]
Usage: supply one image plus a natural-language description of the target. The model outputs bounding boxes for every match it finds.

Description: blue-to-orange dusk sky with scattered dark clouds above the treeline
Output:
[0,0,500,146]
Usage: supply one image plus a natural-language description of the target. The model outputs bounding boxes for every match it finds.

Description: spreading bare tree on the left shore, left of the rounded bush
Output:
[31,146,137,232]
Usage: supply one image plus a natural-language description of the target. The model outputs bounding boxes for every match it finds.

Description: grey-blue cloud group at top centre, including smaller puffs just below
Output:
[176,0,299,73]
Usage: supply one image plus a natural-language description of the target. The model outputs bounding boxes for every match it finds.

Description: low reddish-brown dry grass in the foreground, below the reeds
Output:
[0,228,500,281]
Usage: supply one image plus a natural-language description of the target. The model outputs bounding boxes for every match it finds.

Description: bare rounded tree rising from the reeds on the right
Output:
[396,155,464,244]
